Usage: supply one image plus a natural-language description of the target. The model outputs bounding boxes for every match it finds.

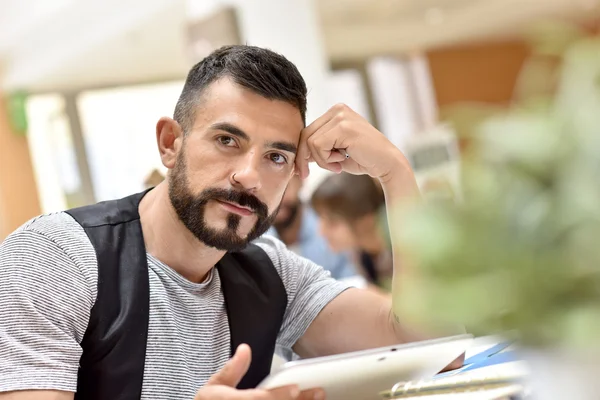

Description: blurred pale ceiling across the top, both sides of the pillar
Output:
[0,0,600,91]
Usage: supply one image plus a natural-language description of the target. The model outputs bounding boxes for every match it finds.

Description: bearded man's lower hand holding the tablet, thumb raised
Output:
[195,344,325,400]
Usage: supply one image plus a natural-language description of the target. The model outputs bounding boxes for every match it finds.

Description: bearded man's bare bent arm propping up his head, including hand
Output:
[294,105,462,366]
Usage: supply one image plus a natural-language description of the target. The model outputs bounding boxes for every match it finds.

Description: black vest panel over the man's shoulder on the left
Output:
[67,192,150,400]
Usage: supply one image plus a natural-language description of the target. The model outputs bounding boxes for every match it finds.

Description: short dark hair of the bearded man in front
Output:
[173,45,306,132]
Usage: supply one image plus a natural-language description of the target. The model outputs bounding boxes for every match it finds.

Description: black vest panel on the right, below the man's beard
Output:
[217,244,287,389]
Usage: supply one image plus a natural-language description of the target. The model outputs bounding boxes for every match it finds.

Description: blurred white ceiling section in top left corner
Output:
[0,0,189,92]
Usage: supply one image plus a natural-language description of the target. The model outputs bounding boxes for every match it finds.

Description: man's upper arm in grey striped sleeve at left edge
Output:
[0,217,95,400]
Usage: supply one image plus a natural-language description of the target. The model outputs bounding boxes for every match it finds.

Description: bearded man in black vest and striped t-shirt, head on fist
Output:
[0,46,460,400]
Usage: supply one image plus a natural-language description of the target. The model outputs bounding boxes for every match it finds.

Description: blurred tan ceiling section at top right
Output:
[317,0,600,61]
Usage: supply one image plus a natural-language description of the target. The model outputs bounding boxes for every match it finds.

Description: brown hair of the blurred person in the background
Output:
[311,172,385,221]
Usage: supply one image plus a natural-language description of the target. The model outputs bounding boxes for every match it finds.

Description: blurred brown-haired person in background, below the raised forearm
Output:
[311,173,393,290]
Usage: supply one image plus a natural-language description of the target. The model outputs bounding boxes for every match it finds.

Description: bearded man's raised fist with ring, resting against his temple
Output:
[296,104,410,179]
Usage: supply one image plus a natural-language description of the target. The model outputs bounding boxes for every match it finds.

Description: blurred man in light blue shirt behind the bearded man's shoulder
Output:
[267,175,364,285]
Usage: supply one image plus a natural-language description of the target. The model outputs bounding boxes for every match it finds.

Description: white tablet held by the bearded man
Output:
[258,335,473,400]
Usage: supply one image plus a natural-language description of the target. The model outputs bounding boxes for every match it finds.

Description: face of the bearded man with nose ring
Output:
[169,79,303,251]
